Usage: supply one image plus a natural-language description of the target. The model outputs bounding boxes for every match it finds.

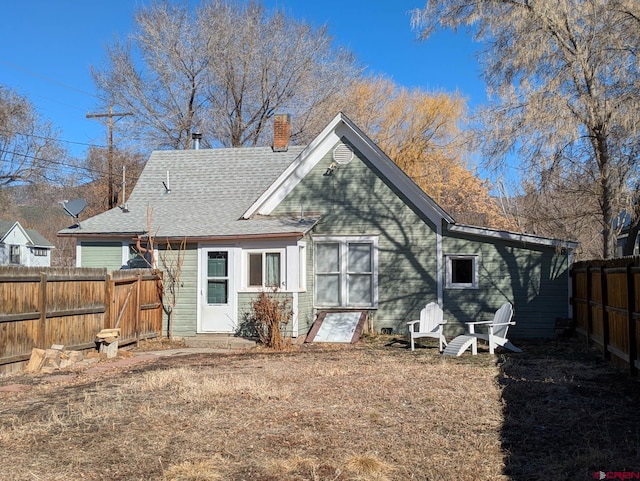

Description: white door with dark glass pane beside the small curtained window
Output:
[200,248,237,333]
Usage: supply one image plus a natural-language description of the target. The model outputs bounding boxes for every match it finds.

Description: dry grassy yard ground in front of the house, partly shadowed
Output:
[0,336,640,481]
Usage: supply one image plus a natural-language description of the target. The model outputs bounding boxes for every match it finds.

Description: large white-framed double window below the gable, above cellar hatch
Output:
[314,237,378,307]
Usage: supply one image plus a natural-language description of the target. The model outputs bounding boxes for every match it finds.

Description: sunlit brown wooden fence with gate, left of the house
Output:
[0,266,162,373]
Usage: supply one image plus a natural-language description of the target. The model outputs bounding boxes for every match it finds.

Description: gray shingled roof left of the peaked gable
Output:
[60,146,315,238]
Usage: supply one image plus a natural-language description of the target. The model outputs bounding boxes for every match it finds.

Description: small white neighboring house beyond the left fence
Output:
[0,220,54,267]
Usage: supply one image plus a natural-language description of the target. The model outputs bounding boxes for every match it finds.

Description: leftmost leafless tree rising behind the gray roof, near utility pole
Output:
[92,2,209,149]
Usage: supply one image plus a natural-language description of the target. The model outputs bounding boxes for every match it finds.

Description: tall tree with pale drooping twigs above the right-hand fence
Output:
[413,0,640,257]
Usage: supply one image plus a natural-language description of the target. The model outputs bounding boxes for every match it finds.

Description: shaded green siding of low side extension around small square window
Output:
[443,234,569,338]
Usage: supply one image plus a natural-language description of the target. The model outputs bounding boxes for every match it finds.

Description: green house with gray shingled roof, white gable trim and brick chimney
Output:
[59,114,576,337]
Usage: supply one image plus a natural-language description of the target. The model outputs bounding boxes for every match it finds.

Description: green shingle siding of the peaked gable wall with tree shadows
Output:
[274,139,437,334]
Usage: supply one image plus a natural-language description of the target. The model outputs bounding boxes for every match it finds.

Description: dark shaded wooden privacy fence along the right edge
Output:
[571,257,640,376]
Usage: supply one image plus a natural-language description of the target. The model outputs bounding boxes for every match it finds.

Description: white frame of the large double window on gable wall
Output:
[313,236,378,310]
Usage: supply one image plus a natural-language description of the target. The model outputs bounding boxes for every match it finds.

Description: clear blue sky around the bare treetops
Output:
[0,0,485,155]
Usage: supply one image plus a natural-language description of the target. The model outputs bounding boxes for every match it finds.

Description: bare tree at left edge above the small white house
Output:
[0,86,65,187]
